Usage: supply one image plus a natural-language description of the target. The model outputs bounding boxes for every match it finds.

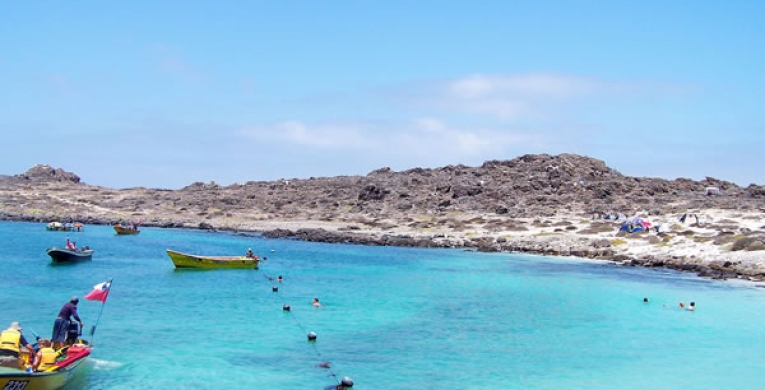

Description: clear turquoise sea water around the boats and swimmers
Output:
[0,222,765,390]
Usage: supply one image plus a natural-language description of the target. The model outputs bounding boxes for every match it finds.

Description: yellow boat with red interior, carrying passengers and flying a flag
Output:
[0,345,91,390]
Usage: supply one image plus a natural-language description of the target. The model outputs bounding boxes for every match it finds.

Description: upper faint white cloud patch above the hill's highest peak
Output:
[388,73,698,123]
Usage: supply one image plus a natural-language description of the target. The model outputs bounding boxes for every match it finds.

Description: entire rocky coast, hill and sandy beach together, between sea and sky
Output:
[0,155,765,282]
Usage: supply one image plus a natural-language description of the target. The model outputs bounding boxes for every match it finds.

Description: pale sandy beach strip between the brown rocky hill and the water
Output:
[203,210,765,281]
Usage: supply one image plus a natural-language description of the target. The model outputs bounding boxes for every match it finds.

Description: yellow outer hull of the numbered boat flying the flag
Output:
[0,350,90,390]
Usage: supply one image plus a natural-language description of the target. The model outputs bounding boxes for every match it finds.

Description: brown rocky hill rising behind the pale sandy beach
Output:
[0,154,765,228]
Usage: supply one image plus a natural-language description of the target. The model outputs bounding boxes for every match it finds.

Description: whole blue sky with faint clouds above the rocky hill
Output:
[0,0,765,189]
